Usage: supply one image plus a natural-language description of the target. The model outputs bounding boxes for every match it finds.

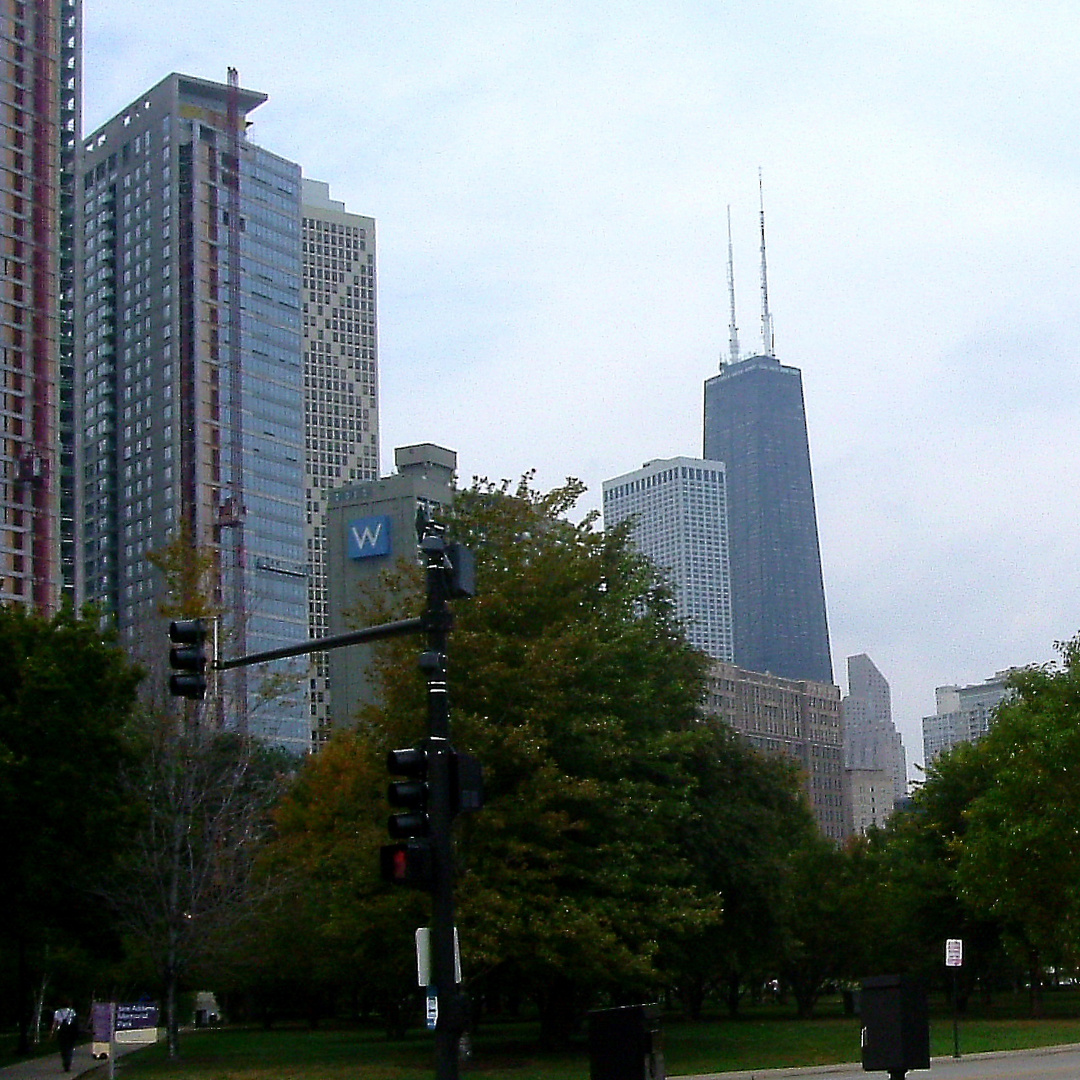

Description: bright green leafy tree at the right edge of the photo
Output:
[957,637,1080,1009]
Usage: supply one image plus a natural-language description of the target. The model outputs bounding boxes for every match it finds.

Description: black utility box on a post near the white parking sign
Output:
[860,975,930,1080]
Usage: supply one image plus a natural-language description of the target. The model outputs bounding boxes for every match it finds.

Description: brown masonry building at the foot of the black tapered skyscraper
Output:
[704,663,848,842]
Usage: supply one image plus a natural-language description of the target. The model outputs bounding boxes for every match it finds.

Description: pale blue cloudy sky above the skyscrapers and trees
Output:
[84,0,1080,775]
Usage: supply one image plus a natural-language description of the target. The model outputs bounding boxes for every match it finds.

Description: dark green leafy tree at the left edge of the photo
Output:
[0,607,140,1048]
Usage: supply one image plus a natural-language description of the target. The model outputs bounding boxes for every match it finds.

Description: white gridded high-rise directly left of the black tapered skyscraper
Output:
[604,458,733,663]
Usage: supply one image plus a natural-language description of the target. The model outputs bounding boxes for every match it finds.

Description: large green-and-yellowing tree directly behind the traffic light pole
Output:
[270,477,721,1042]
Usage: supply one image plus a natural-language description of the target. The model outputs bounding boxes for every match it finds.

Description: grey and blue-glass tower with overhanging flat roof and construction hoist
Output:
[80,72,310,750]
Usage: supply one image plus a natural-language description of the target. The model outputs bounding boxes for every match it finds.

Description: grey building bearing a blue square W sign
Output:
[323,443,458,738]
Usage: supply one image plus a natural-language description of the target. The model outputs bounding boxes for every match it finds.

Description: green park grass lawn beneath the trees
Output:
[90,993,1080,1080]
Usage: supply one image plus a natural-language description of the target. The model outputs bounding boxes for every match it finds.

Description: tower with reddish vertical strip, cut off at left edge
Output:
[0,0,82,613]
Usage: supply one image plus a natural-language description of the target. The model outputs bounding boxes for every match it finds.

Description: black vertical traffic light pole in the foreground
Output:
[420,522,465,1080]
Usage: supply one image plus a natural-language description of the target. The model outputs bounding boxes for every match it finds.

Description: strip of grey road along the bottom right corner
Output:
[680,1043,1080,1080]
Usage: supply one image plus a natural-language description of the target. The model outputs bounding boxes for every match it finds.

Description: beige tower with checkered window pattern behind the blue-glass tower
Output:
[301,179,379,745]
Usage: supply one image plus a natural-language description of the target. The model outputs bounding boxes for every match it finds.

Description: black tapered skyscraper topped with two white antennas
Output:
[703,356,833,683]
